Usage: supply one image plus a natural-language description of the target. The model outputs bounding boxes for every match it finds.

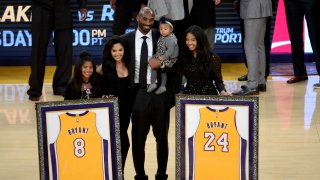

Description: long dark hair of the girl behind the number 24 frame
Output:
[178,25,213,77]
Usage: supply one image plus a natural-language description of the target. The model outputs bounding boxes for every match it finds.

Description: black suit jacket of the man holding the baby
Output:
[121,29,176,107]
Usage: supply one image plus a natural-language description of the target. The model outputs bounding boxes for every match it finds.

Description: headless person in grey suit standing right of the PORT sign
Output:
[233,0,272,95]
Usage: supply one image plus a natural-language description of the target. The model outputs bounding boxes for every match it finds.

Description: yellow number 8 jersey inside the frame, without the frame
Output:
[56,112,104,180]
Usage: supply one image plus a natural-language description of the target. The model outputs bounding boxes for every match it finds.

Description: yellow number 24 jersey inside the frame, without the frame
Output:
[194,108,240,180]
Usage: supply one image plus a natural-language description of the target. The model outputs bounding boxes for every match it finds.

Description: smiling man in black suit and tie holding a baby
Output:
[123,7,174,180]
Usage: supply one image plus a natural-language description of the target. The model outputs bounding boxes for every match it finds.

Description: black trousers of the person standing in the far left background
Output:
[28,3,73,95]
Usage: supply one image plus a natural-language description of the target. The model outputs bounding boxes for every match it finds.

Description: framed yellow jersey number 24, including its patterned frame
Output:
[175,94,259,180]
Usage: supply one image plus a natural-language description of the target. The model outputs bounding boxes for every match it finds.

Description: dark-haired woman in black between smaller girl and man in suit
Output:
[102,36,132,170]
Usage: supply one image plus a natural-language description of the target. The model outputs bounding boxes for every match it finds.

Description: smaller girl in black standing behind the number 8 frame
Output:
[64,51,103,100]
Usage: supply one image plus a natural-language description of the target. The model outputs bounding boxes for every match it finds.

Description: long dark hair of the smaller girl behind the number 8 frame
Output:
[72,51,98,93]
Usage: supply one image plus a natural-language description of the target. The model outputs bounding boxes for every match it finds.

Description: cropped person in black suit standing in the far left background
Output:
[27,0,87,101]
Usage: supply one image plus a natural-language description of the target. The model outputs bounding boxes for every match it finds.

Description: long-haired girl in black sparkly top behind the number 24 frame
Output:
[175,26,231,96]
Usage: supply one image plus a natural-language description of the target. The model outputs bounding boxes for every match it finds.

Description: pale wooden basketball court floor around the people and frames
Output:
[0,64,320,180]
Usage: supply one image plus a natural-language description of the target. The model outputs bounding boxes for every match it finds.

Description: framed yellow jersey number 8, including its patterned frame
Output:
[36,97,123,180]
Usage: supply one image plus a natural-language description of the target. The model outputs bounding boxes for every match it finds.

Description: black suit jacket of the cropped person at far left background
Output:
[32,0,87,29]
